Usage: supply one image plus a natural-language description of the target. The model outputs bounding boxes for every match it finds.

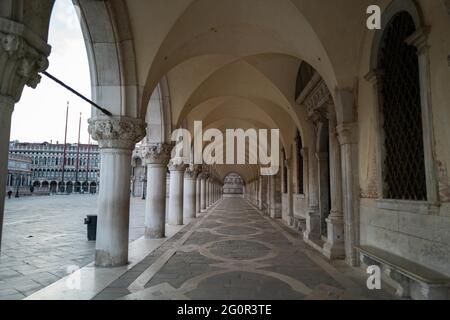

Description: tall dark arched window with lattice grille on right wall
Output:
[378,12,427,201]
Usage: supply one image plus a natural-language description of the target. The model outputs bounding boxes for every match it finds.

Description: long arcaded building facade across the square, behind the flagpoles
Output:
[8,141,100,193]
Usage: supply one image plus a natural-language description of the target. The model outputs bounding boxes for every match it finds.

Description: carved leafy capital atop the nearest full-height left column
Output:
[88,117,146,150]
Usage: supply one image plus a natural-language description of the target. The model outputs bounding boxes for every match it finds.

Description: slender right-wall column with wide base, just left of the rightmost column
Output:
[323,113,345,259]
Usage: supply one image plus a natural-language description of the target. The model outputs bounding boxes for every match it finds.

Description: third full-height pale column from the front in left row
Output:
[169,160,186,225]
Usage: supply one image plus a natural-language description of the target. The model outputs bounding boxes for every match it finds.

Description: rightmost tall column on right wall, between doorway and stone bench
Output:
[337,123,359,266]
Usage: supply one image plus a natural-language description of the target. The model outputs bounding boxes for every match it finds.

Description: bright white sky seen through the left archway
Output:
[11,0,91,143]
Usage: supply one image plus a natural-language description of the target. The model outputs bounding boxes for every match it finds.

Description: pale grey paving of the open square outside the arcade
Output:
[0,194,145,300]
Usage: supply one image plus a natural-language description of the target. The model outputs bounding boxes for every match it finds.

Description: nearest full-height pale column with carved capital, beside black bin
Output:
[89,117,146,267]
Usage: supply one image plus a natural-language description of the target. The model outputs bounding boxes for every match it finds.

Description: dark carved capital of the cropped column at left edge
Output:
[0,29,50,101]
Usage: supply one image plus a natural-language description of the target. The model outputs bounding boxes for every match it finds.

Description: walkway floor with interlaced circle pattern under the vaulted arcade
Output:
[95,198,392,300]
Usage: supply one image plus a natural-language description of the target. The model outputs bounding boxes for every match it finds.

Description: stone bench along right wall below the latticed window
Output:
[356,246,450,300]
